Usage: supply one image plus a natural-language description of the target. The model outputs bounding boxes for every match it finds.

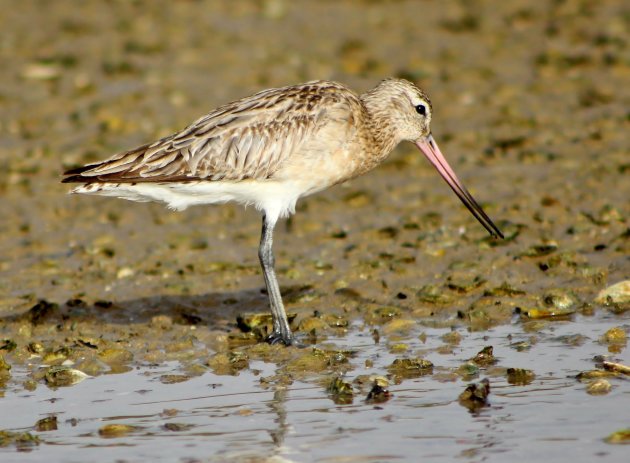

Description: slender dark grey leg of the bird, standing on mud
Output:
[258,215,294,346]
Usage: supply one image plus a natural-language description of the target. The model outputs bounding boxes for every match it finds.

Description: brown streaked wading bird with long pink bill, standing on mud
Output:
[63,79,502,345]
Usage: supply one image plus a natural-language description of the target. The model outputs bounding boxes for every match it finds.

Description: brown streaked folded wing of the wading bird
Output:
[64,81,357,183]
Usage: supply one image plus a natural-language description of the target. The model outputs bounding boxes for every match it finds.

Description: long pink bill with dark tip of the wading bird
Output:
[416,134,503,238]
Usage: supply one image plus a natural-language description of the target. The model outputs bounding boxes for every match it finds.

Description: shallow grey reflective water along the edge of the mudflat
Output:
[0,316,630,462]
